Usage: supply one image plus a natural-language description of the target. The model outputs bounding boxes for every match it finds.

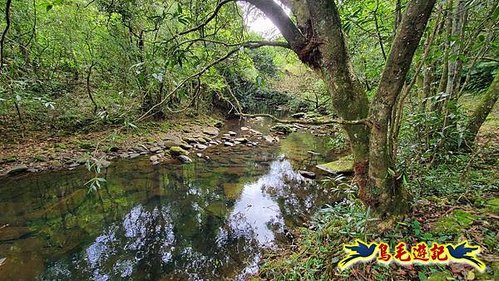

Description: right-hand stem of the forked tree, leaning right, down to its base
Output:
[364,0,435,215]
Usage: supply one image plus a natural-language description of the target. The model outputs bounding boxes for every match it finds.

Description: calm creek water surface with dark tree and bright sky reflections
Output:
[0,117,340,280]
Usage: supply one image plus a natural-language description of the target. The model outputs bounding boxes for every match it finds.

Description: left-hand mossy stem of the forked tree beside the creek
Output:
[308,0,369,188]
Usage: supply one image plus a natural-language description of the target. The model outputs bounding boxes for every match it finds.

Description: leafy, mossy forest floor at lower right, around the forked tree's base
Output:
[254,97,499,281]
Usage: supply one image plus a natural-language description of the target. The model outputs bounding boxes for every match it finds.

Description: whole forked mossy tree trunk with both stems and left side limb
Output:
[246,0,435,216]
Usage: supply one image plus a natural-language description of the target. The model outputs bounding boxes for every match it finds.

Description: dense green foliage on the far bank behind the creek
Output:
[0,0,294,135]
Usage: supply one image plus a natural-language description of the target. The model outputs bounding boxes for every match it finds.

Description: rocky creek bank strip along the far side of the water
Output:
[0,114,342,178]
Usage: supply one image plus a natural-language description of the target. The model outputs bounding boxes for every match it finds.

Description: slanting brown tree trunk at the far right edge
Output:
[466,73,499,147]
